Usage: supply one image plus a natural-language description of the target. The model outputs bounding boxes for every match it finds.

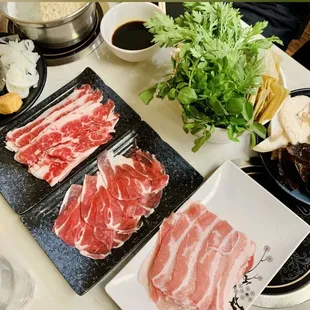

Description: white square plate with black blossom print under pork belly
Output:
[106,161,310,310]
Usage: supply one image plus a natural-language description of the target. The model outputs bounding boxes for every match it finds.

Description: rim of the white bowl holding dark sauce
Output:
[100,2,165,55]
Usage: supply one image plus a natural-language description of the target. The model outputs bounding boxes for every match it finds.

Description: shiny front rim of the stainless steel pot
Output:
[0,2,96,28]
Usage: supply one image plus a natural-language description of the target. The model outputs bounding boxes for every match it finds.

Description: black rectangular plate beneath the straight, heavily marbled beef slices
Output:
[0,68,141,214]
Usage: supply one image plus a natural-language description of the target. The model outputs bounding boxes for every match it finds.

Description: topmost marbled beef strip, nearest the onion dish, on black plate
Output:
[6,84,92,151]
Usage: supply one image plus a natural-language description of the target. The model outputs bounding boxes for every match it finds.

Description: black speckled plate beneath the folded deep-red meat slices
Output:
[22,122,203,295]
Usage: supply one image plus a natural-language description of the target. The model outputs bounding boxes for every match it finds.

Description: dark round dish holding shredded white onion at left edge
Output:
[0,32,47,127]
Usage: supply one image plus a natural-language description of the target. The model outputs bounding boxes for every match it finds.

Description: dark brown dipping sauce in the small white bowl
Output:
[112,21,154,51]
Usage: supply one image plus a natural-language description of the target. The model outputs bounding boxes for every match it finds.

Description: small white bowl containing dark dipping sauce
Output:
[100,2,164,62]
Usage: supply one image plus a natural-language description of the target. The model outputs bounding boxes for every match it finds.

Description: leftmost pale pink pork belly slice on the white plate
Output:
[150,204,206,291]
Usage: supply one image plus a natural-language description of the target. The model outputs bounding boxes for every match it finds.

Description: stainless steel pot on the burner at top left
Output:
[0,2,96,48]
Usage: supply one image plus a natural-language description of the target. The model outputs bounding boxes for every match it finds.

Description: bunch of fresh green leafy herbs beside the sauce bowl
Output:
[140,2,281,152]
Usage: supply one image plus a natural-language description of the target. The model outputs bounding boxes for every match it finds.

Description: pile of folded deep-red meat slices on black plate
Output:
[53,149,169,259]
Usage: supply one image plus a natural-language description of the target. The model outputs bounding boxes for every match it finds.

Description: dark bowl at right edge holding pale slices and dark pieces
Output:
[257,88,310,206]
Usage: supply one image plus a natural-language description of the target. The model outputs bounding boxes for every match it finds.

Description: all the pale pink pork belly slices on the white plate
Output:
[139,203,256,310]
